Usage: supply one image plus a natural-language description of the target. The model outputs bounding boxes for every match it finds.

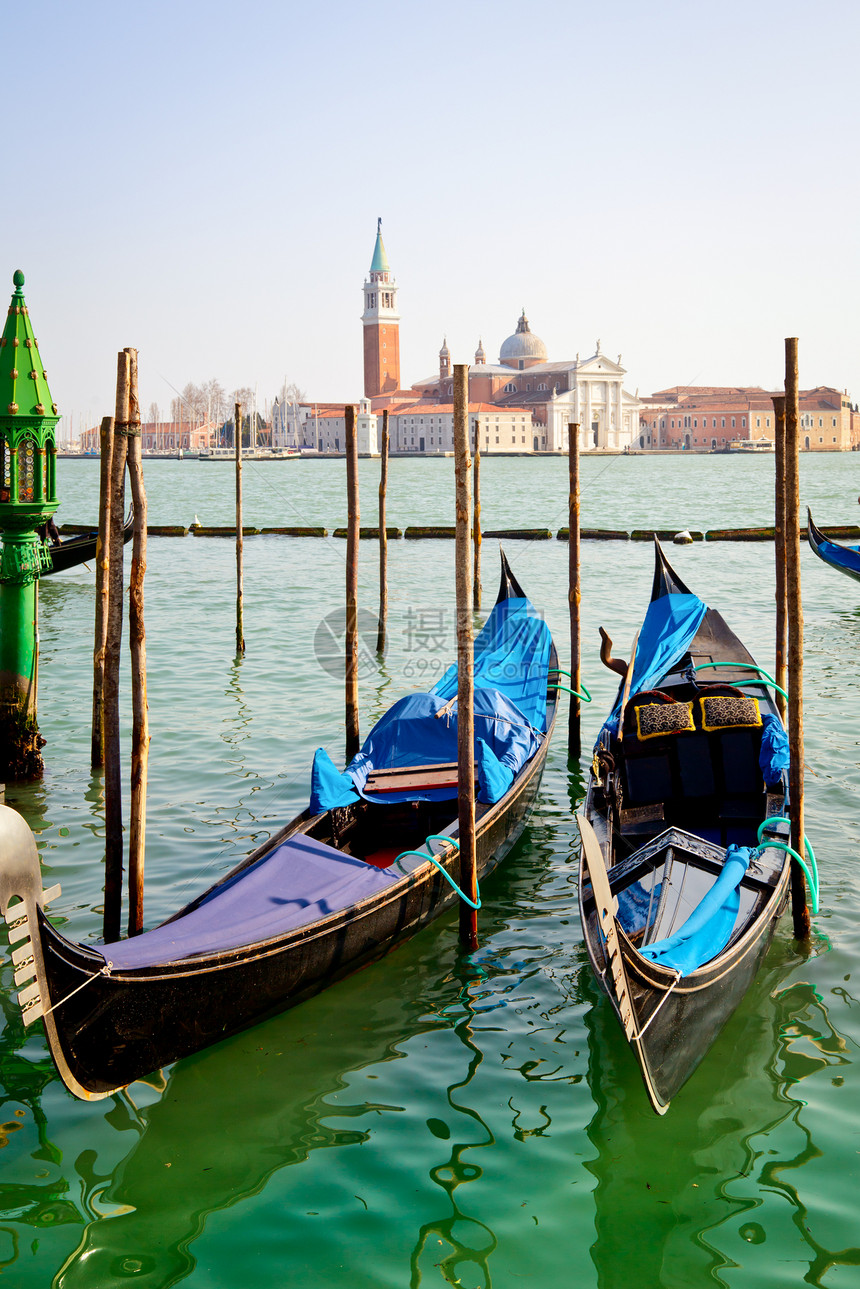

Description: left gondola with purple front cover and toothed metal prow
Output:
[0,556,558,1100]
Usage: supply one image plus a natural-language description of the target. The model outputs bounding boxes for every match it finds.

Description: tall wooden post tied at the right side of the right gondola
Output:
[785,336,810,940]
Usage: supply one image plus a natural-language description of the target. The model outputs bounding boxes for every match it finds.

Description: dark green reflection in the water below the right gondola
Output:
[585,941,860,1289]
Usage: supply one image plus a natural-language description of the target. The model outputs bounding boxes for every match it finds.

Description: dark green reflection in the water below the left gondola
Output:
[53,974,444,1289]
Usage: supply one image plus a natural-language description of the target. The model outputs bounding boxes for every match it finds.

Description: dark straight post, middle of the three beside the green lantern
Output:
[104,349,132,942]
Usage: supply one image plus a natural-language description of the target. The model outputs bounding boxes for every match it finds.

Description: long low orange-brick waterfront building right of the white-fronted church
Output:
[636,385,860,452]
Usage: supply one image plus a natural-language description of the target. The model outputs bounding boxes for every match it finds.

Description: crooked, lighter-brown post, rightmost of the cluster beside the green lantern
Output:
[125,349,150,936]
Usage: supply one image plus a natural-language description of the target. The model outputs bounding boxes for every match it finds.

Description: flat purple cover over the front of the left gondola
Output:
[99,834,402,971]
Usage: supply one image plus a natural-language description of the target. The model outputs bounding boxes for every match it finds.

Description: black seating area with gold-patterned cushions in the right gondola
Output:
[611,682,774,855]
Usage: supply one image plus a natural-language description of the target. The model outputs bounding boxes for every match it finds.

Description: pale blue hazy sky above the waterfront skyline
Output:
[0,0,860,434]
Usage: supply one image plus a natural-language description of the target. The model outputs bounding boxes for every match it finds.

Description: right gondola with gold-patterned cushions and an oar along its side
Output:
[578,543,790,1114]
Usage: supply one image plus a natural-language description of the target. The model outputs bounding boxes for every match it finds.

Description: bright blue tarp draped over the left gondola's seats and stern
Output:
[311,597,552,815]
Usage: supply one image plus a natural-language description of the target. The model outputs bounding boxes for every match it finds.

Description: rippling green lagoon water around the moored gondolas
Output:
[0,456,860,1289]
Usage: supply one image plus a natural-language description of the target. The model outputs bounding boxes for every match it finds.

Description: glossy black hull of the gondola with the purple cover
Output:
[21,704,554,1100]
